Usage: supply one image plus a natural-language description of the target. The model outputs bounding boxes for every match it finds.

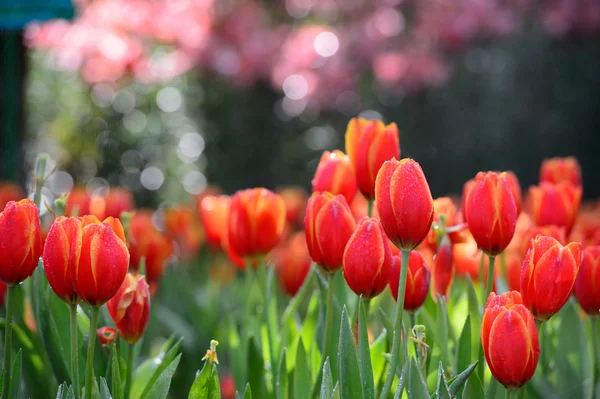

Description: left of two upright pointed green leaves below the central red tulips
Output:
[338,306,362,399]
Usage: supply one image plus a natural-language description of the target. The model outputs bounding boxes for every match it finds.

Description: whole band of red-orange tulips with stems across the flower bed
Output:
[0,118,600,399]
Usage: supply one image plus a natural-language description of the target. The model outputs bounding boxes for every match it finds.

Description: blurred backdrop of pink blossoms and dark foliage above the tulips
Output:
[0,0,600,206]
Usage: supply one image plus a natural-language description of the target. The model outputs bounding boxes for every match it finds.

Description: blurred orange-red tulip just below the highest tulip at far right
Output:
[529,181,582,235]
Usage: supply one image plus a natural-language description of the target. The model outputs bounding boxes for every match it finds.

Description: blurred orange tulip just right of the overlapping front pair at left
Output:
[128,210,173,285]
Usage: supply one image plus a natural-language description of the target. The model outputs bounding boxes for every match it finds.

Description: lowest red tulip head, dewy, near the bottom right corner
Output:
[481,291,540,390]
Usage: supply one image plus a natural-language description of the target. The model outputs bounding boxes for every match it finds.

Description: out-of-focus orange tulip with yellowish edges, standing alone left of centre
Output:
[228,188,285,257]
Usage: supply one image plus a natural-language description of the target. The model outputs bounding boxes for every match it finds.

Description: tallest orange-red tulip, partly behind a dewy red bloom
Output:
[346,118,400,201]
